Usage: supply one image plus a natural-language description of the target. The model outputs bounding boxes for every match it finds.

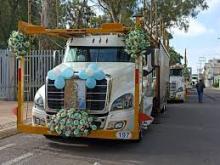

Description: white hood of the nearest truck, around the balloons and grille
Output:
[53,62,135,102]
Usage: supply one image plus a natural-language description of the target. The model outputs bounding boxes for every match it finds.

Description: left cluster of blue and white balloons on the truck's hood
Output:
[47,65,74,89]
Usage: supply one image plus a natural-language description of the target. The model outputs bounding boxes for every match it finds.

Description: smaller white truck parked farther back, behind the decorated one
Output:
[169,64,186,102]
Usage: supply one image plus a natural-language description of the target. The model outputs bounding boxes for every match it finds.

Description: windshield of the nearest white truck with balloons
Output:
[64,47,131,62]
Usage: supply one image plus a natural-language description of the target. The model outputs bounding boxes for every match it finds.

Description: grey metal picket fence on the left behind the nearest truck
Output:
[0,50,64,101]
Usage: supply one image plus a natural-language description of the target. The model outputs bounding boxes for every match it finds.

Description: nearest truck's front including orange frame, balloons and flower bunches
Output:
[12,22,156,140]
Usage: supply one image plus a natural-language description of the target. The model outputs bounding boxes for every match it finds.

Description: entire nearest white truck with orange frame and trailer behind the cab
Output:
[18,22,169,140]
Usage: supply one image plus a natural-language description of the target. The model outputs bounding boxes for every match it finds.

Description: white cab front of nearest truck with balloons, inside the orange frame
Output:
[33,35,138,136]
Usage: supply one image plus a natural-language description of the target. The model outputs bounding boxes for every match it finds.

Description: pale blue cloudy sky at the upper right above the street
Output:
[170,0,220,73]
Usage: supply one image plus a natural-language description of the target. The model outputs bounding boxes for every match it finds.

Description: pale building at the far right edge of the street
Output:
[203,58,220,87]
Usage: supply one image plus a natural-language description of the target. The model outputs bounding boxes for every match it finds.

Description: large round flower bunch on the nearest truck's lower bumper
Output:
[48,108,97,137]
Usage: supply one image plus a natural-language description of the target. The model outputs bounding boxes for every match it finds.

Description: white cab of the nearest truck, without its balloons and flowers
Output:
[32,34,152,138]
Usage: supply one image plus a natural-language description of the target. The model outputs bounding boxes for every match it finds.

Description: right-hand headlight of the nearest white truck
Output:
[111,93,133,111]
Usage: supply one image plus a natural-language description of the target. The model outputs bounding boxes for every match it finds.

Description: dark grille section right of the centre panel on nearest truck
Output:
[86,79,107,111]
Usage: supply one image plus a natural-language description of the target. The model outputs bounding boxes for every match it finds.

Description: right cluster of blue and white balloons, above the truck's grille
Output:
[79,63,105,89]
